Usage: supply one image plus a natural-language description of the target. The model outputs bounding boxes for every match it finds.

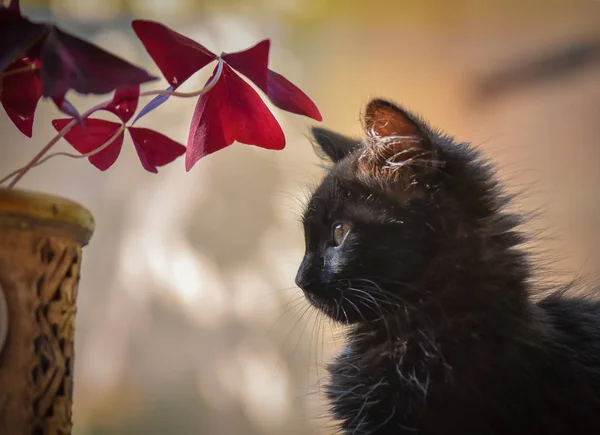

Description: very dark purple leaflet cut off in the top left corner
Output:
[0,8,49,72]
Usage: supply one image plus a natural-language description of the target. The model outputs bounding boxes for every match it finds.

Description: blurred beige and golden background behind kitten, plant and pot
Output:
[0,0,600,435]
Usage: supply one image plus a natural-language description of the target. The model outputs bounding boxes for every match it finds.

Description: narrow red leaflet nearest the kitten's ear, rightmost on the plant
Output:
[267,70,323,121]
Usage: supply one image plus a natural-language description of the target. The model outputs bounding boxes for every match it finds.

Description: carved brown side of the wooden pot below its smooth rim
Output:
[0,228,81,435]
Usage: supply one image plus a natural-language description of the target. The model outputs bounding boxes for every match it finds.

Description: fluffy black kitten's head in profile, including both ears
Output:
[296,100,506,323]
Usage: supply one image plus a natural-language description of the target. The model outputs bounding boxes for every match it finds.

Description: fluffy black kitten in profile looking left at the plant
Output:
[296,100,600,435]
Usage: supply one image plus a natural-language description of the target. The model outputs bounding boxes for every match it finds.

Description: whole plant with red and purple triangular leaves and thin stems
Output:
[0,0,322,188]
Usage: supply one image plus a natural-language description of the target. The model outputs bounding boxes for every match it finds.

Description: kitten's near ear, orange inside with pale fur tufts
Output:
[358,99,439,184]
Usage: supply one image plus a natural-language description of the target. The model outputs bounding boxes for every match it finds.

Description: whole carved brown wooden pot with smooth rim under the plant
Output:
[0,189,94,435]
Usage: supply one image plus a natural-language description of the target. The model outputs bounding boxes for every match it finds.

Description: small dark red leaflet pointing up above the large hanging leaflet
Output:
[222,39,271,93]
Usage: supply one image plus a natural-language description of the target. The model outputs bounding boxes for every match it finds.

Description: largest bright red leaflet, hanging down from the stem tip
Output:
[185,64,285,171]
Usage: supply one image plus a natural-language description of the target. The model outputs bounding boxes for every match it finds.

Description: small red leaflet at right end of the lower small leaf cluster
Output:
[127,127,185,174]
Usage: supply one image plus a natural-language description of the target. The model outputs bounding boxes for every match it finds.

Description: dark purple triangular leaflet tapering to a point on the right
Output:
[41,26,155,97]
